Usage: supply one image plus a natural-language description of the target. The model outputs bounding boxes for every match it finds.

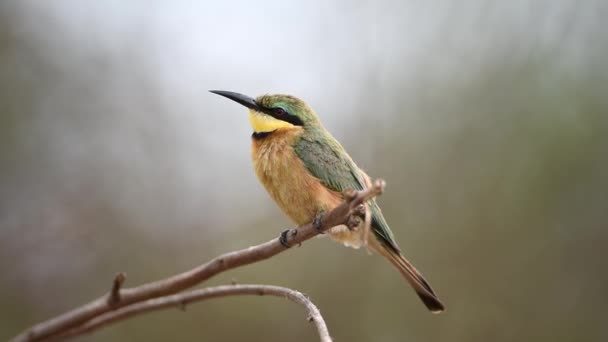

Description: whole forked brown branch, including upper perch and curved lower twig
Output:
[12,179,385,342]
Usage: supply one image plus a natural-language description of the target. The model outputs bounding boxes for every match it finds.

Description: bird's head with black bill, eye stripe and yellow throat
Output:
[211,90,321,133]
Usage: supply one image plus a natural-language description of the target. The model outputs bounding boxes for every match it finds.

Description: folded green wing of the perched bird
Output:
[293,133,399,252]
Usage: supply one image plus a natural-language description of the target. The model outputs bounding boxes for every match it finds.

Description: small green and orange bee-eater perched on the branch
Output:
[211,90,444,313]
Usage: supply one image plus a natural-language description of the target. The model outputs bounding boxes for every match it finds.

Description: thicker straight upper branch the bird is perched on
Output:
[13,180,385,342]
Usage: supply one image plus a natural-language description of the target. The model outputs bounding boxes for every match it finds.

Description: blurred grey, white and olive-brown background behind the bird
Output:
[0,0,608,341]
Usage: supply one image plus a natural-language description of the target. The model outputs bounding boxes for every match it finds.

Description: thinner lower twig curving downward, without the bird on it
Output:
[57,284,332,342]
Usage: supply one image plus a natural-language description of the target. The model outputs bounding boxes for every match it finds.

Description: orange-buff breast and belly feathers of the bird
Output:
[252,129,341,224]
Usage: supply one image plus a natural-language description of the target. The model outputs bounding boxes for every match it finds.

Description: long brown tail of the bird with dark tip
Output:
[370,239,445,313]
